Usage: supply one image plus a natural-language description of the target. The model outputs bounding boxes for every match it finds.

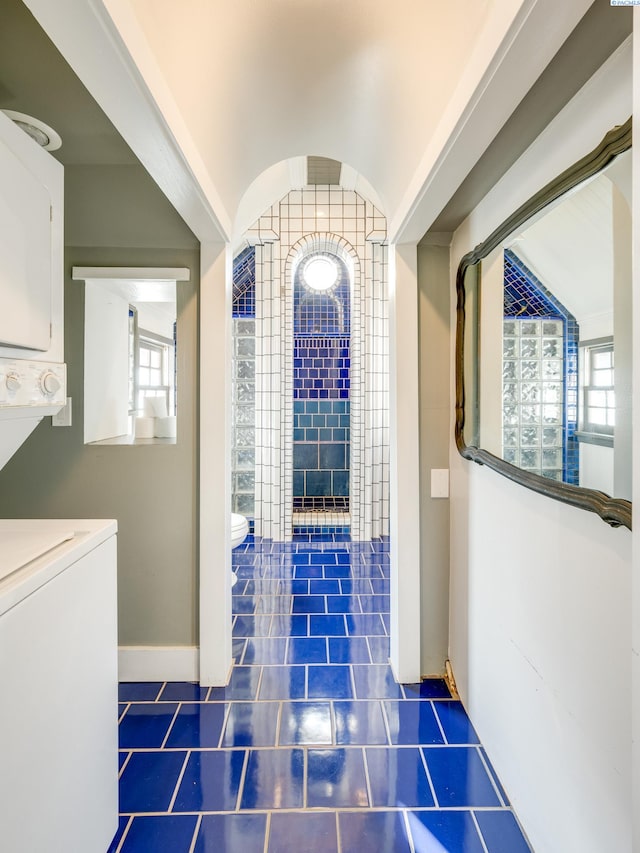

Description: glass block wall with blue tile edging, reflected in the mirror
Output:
[502,249,579,484]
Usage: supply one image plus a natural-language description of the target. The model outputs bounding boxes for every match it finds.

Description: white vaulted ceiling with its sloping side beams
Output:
[25,0,591,240]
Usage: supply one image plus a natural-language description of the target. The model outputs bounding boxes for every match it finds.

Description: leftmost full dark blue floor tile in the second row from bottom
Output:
[120,752,187,814]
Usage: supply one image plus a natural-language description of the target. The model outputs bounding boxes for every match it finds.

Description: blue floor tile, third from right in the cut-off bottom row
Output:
[338,811,410,853]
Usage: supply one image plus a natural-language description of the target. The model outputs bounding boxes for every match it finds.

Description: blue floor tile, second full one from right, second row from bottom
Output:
[366,747,434,808]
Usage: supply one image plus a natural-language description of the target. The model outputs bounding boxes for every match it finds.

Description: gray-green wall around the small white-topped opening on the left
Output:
[0,166,200,645]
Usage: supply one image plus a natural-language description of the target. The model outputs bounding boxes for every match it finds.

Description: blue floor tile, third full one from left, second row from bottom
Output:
[240,748,304,809]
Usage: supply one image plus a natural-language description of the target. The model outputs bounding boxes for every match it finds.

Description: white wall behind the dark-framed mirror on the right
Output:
[450,38,637,853]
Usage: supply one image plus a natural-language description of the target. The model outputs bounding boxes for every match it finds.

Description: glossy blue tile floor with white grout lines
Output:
[109,534,530,853]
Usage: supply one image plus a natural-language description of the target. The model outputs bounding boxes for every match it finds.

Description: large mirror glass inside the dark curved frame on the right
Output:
[462,150,632,500]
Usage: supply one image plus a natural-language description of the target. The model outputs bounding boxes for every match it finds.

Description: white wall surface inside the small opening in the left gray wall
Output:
[84,283,129,442]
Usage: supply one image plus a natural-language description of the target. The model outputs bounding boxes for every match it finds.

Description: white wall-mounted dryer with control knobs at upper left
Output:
[0,112,67,468]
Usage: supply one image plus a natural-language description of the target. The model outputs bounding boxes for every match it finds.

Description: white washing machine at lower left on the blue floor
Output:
[0,519,118,853]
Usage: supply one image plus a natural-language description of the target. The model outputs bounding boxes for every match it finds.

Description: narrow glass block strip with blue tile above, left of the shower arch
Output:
[231,247,256,518]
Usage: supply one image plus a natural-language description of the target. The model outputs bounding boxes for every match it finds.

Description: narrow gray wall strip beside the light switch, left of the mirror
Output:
[418,238,452,675]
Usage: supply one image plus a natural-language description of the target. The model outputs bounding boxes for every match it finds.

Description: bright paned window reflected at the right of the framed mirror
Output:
[580,338,616,436]
